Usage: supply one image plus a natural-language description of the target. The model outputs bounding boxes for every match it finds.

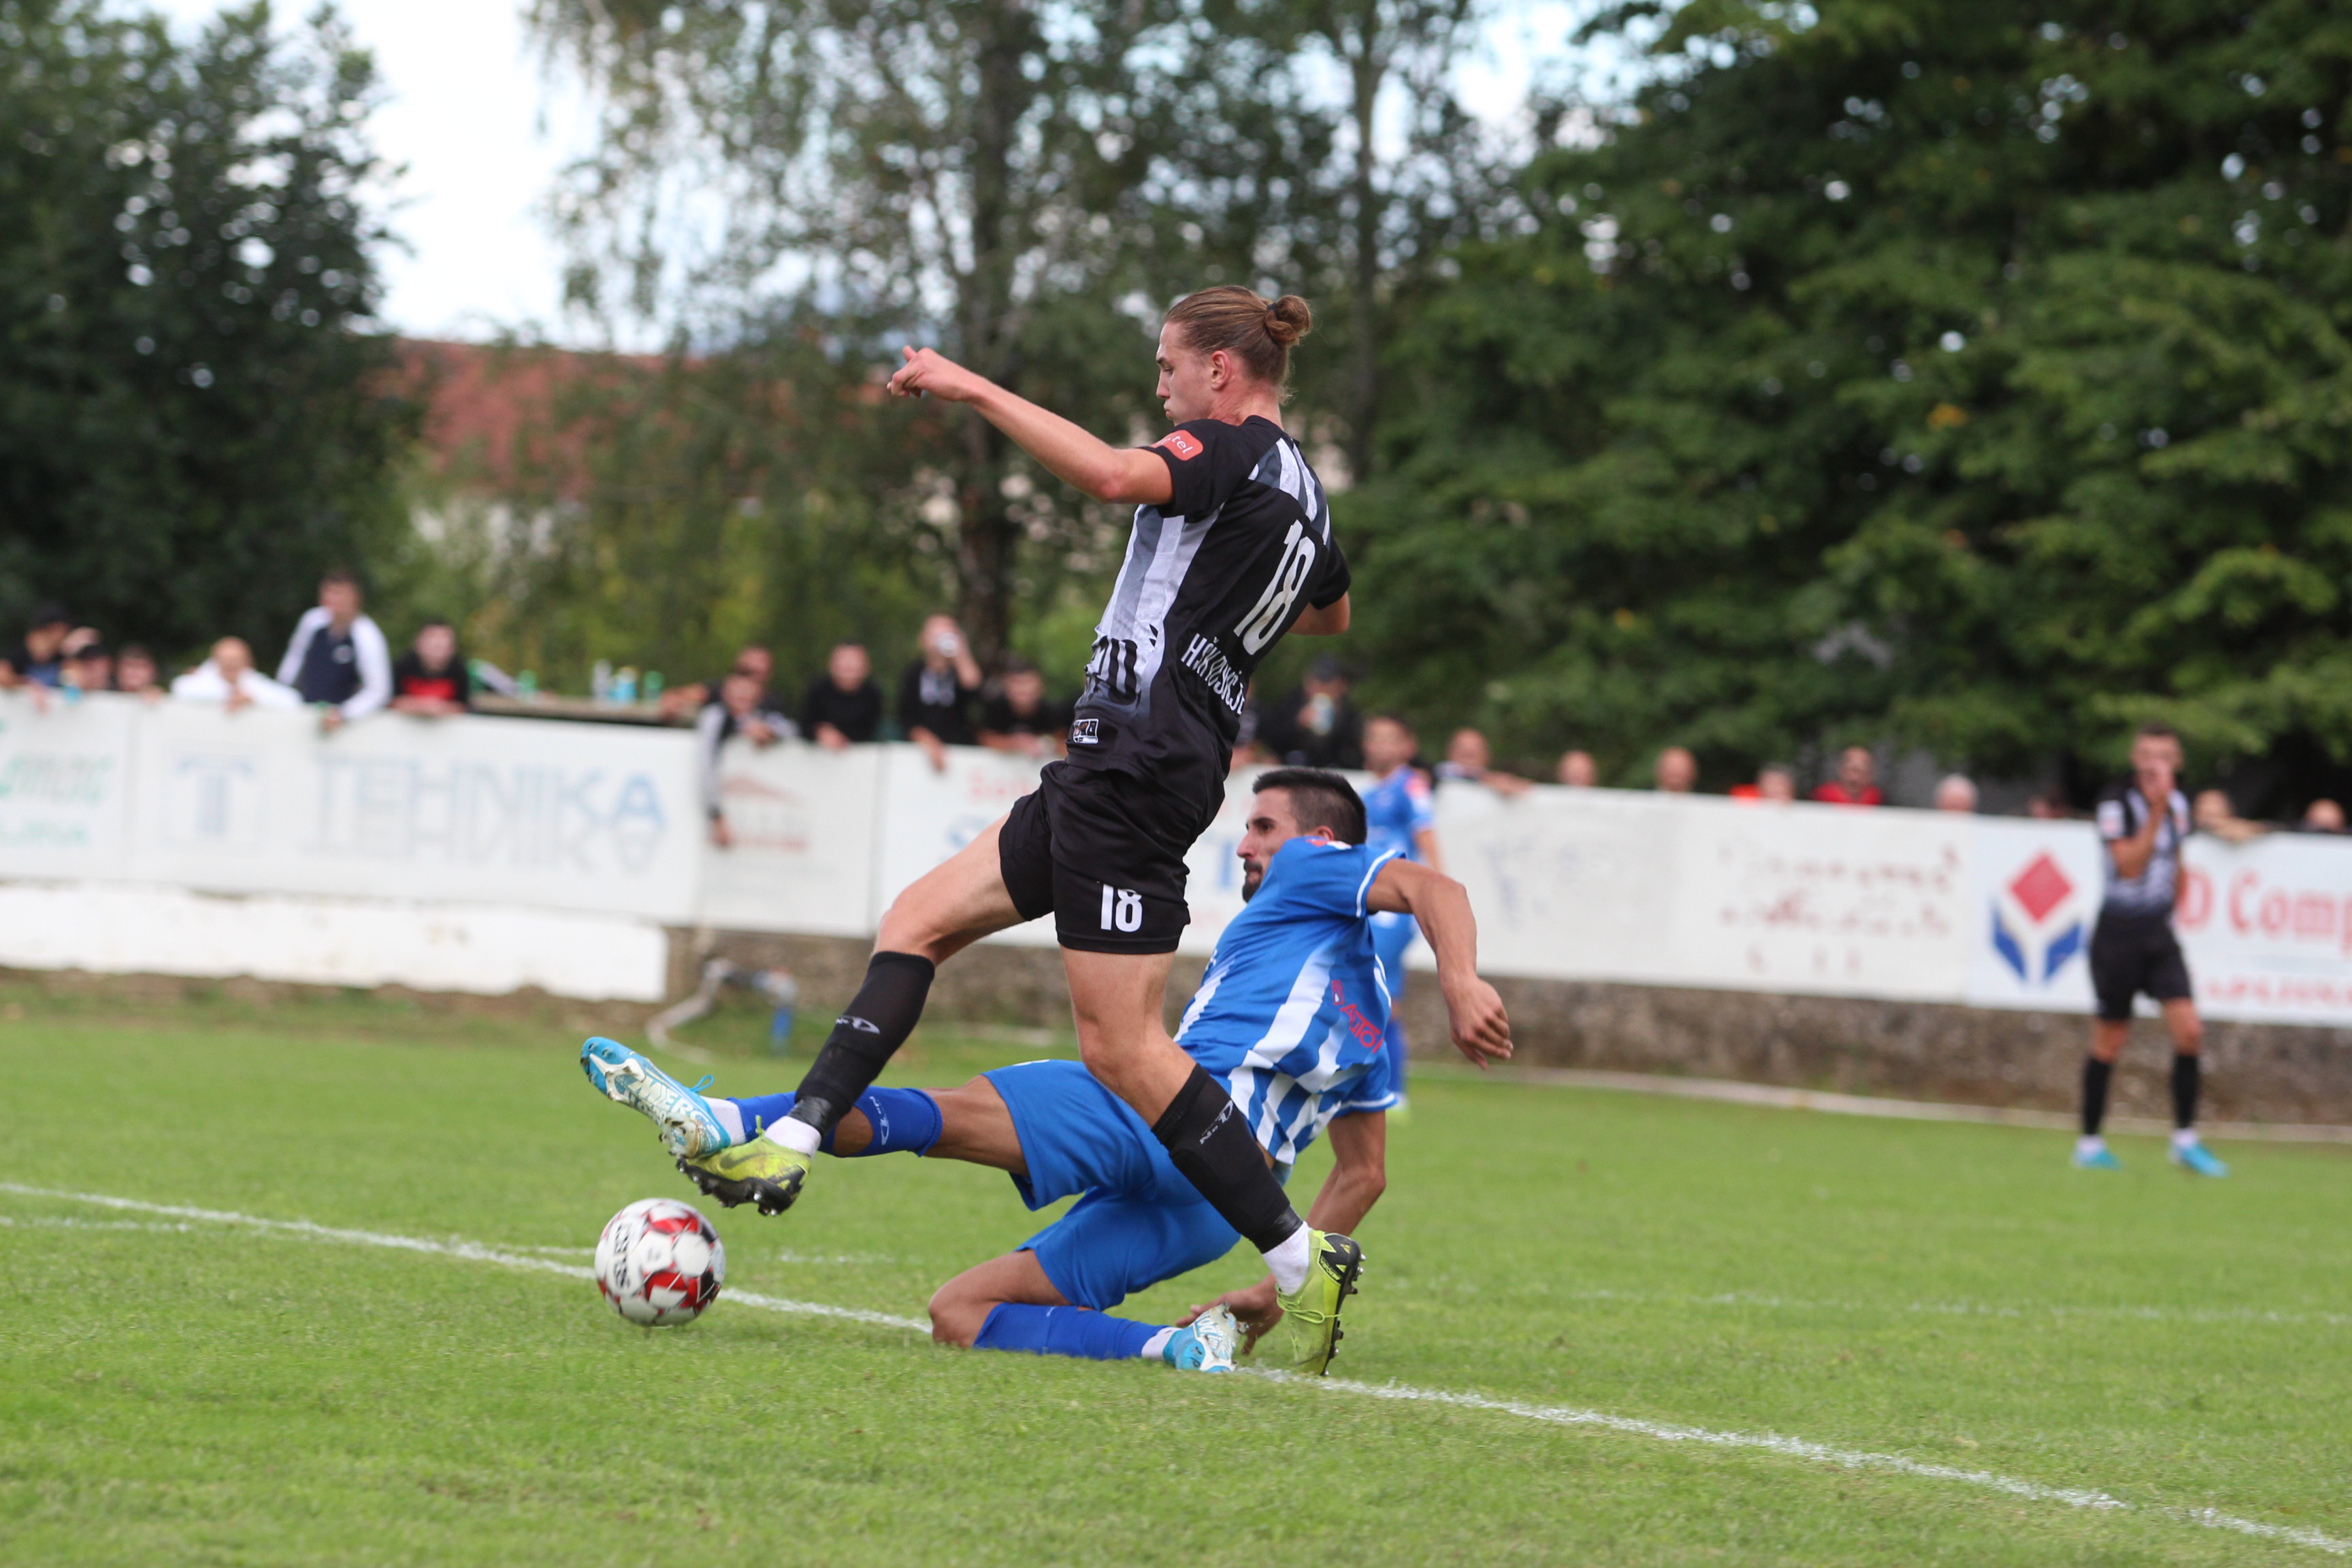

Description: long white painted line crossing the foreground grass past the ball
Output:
[0,1182,2352,1556]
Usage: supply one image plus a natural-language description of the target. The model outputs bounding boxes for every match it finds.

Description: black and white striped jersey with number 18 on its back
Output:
[1070,416,1348,818]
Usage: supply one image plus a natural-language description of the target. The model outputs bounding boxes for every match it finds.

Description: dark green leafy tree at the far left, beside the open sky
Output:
[0,0,412,651]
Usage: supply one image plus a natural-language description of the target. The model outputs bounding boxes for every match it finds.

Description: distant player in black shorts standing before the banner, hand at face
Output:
[2074,724,2230,1175]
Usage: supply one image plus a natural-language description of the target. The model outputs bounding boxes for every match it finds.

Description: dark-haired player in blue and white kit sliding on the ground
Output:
[581,769,1510,1373]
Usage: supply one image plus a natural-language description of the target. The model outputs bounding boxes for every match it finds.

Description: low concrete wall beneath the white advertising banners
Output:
[670,933,2352,1126]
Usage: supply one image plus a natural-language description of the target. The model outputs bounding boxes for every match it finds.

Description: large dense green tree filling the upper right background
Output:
[1345,0,2352,804]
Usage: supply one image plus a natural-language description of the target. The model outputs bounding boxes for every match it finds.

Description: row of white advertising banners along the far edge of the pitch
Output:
[0,693,2352,1025]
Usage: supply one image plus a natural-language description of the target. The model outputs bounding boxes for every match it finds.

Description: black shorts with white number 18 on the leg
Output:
[997,762,1213,952]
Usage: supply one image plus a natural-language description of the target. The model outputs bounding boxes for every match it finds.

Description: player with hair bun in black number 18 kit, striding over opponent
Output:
[680,287,1362,1371]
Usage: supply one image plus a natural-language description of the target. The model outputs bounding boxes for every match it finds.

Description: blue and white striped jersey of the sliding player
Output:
[1176,839,1397,1166]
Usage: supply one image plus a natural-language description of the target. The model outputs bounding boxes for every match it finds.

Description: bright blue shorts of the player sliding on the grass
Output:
[988,1062,1239,1311]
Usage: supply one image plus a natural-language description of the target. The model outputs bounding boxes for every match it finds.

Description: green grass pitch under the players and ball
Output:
[0,987,2352,1568]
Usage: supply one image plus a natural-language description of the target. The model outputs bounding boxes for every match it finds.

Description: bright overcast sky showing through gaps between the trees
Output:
[158,0,1590,343]
